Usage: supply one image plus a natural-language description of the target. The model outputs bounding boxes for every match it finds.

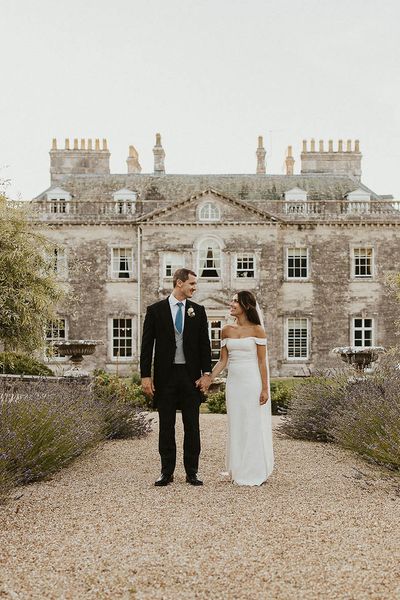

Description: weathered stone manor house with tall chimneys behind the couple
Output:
[33,134,400,376]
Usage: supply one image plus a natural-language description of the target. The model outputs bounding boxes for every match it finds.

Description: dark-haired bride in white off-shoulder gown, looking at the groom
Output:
[211,291,274,485]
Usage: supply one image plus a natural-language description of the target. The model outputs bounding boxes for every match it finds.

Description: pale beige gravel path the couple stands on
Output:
[0,414,400,600]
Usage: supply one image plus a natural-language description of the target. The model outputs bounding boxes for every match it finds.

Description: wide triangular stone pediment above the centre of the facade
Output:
[140,188,282,225]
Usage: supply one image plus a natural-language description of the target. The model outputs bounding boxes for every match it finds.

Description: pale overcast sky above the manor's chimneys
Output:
[0,0,400,199]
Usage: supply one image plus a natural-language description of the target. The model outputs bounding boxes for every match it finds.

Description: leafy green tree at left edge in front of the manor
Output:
[0,192,62,351]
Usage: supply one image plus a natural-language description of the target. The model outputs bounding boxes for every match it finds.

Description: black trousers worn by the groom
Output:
[157,365,201,475]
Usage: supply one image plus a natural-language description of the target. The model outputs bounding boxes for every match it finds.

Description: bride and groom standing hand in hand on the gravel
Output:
[140,268,274,486]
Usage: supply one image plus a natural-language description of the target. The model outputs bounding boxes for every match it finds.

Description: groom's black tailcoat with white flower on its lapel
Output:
[140,298,211,406]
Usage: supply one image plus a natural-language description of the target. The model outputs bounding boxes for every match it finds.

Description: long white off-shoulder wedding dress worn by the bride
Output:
[222,337,274,485]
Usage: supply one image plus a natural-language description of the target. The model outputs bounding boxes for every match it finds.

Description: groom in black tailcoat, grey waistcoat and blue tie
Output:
[140,269,211,486]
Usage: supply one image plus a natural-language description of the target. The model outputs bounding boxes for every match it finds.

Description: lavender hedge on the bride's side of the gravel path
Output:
[280,349,400,470]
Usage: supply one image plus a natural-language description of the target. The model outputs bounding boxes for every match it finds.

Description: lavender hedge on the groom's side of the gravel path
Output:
[0,379,151,499]
